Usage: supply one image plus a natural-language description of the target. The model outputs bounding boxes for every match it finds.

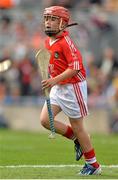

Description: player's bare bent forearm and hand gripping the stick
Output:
[42,68,78,89]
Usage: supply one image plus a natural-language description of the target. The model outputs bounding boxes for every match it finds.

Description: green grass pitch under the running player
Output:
[0,129,118,179]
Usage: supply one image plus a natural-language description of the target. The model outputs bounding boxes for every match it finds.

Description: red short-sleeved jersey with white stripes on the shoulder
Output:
[45,31,86,84]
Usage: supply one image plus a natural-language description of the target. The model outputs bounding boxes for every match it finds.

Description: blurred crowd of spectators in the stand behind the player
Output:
[0,0,118,107]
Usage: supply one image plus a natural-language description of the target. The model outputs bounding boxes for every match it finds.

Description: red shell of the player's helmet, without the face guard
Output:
[44,6,70,23]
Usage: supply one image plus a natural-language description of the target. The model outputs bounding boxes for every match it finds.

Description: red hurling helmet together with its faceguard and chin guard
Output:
[44,6,70,37]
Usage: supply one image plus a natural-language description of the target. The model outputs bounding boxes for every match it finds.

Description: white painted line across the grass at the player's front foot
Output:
[0,164,118,168]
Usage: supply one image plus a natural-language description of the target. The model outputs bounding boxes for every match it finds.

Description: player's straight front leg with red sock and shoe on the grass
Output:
[69,118,101,175]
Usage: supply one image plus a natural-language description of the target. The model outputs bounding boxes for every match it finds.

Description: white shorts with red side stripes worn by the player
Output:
[50,81,88,119]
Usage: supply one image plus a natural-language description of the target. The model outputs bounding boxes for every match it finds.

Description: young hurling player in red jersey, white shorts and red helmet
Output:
[40,6,101,175]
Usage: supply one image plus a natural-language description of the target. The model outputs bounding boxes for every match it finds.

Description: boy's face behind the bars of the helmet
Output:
[44,16,60,32]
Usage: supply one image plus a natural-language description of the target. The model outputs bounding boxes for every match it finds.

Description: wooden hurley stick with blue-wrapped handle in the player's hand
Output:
[35,49,55,139]
